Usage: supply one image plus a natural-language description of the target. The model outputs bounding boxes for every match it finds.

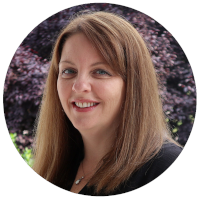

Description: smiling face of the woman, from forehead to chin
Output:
[57,33,124,136]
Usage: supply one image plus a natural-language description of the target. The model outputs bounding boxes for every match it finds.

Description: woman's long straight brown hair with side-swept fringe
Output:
[33,12,177,193]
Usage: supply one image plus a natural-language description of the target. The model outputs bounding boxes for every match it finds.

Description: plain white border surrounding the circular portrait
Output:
[0,0,200,200]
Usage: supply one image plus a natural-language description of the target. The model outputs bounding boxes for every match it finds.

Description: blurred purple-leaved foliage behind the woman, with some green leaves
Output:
[4,3,196,159]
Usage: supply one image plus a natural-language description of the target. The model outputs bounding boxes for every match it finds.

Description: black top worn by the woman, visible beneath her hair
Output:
[79,143,182,196]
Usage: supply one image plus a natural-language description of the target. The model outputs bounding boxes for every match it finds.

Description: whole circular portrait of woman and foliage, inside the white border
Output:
[3,3,196,196]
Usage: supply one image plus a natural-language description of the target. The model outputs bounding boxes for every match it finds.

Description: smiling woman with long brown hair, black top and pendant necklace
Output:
[33,12,181,196]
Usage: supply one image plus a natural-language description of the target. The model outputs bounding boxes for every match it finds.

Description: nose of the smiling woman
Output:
[72,76,91,93]
